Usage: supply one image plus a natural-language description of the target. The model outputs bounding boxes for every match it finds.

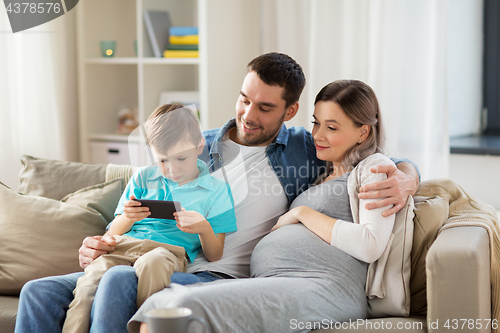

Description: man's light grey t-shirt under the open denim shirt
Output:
[188,134,288,278]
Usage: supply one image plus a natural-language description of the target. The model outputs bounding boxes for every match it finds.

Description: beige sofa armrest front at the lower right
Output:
[426,226,491,333]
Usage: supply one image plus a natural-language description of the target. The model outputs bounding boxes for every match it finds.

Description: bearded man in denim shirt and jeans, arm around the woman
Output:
[16,53,419,333]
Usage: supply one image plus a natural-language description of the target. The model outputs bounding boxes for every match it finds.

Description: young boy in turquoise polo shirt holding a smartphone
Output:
[63,103,236,333]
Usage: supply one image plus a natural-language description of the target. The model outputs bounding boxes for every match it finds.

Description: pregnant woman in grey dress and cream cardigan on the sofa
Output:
[129,80,395,333]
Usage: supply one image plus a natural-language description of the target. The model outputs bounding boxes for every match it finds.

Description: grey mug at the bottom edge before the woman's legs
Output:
[146,308,208,333]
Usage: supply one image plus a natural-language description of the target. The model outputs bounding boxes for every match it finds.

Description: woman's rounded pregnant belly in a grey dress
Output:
[250,223,367,279]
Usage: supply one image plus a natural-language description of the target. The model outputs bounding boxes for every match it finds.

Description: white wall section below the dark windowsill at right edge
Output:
[449,154,500,210]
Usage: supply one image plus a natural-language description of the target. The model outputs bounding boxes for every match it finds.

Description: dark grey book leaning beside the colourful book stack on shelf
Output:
[144,10,170,58]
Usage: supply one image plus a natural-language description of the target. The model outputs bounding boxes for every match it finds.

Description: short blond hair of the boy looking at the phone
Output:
[146,103,202,154]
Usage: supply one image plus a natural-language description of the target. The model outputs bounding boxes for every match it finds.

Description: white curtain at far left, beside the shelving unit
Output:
[0,10,78,189]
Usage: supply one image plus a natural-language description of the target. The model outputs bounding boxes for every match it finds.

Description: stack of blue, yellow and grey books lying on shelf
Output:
[163,27,198,58]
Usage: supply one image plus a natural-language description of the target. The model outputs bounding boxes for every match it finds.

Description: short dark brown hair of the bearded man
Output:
[247,52,306,108]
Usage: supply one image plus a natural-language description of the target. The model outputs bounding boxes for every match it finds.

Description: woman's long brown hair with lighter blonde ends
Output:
[314,80,384,169]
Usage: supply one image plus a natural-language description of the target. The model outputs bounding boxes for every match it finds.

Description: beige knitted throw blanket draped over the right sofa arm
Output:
[418,179,500,332]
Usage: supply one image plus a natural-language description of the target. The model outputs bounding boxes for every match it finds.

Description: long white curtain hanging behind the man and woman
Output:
[261,0,483,180]
